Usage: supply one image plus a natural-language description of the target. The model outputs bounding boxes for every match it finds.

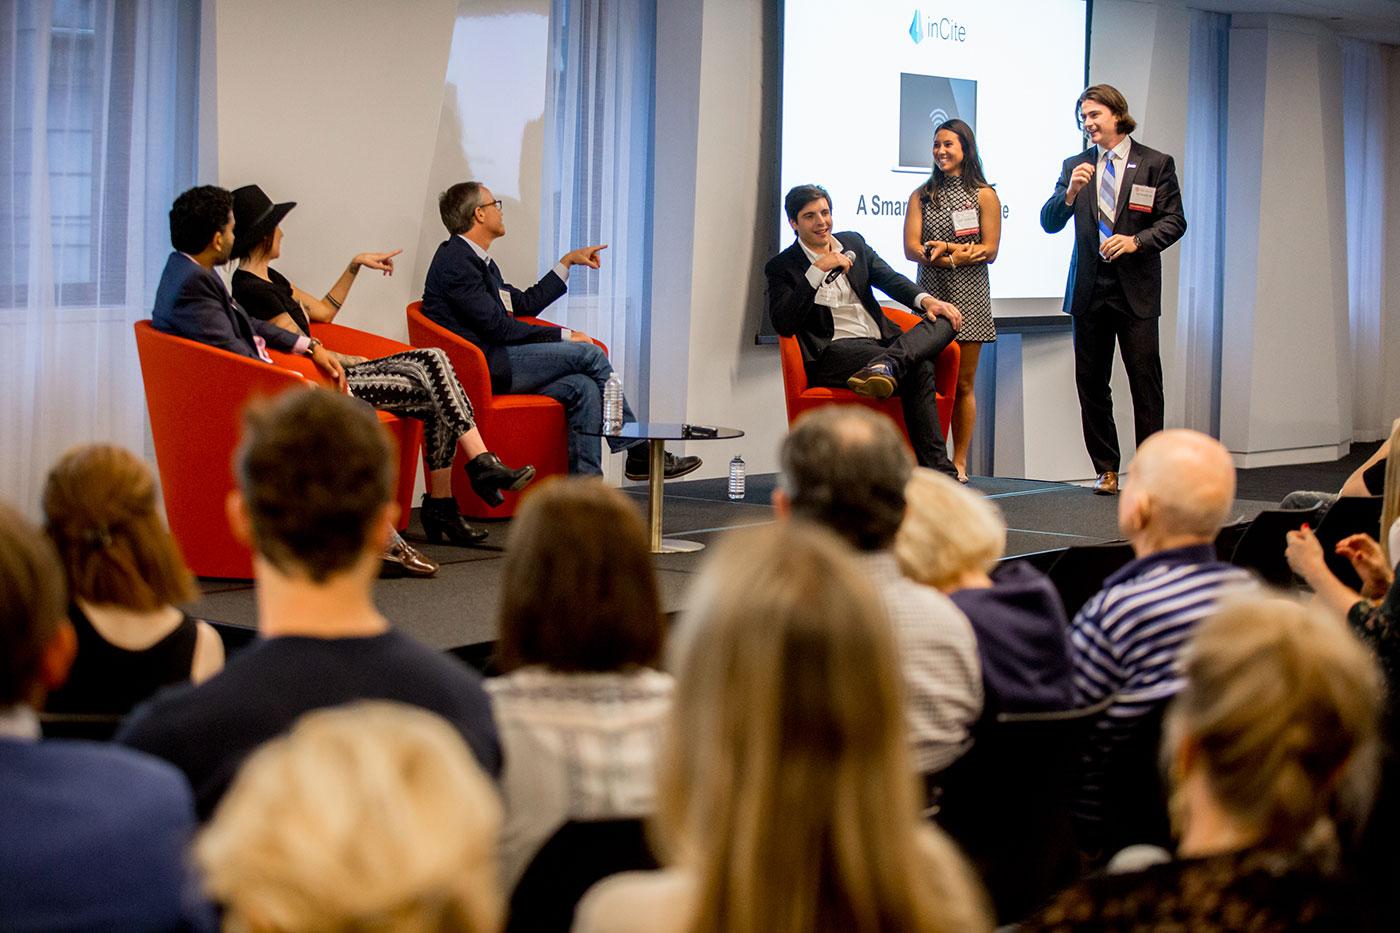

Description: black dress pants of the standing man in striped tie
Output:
[1074,270,1166,474]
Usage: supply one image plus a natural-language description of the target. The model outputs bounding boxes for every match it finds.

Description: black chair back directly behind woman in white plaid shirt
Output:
[505,820,658,933]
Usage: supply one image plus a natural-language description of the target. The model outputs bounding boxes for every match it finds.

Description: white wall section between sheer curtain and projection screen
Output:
[651,0,787,476]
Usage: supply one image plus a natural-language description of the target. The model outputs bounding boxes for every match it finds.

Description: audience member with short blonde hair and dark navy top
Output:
[895,467,1074,713]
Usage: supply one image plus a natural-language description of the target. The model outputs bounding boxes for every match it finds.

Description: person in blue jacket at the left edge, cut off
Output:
[0,506,216,930]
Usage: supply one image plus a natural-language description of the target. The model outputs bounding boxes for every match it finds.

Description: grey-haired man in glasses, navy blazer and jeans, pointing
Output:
[423,182,700,479]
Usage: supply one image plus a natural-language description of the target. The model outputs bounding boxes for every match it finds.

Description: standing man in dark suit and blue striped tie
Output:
[1040,84,1186,496]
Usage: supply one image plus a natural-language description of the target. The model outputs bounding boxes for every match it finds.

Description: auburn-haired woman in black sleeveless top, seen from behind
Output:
[43,444,224,714]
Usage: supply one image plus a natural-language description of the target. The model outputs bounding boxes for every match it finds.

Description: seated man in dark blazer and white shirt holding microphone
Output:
[763,185,962,476]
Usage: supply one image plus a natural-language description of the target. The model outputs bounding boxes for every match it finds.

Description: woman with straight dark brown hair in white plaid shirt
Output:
[486,478,673,891]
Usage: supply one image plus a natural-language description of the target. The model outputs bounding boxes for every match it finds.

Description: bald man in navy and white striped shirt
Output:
[1070,430,1256,855]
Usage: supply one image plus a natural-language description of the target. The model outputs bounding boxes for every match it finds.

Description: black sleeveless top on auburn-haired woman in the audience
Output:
[45,602,199,716]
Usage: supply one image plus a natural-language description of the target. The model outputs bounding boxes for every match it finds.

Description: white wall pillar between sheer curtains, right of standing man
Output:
[1221,15,1351,467]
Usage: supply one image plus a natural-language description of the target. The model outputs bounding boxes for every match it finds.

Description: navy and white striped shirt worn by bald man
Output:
[1070,544,1254,821]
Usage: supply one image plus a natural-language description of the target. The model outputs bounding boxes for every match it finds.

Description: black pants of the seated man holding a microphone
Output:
[806,318,958,476]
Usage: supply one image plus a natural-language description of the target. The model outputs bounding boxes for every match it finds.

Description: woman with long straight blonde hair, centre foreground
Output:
[574,523,988,933]
